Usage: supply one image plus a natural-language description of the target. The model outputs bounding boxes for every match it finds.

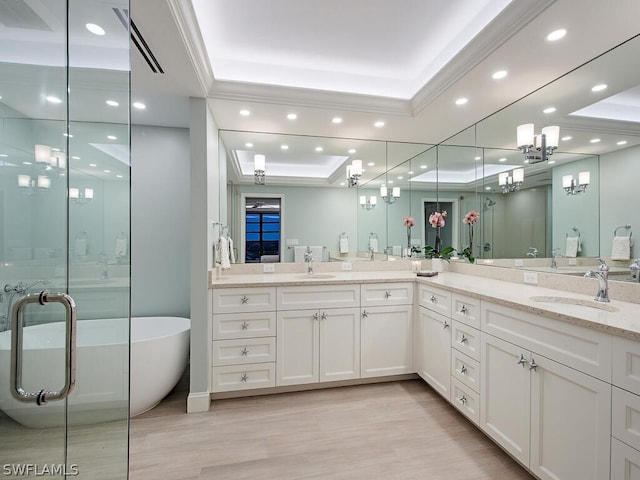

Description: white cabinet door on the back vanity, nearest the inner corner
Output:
[360,305,414,378]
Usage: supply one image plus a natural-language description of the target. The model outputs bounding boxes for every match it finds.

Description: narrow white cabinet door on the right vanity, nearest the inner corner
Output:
[417,307,451,400]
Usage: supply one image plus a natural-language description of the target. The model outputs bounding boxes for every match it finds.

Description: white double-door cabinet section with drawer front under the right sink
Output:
[480,302,611,480]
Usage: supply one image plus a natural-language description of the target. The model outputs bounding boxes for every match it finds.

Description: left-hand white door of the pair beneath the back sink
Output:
[276,310,320,386]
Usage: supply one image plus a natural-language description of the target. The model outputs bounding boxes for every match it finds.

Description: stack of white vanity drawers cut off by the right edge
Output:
[611,336,640,480]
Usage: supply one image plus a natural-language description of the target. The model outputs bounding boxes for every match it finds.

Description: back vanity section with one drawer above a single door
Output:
[360,282,415,378]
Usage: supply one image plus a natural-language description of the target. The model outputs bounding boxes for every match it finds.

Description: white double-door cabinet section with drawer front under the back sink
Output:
[276,285,360,386]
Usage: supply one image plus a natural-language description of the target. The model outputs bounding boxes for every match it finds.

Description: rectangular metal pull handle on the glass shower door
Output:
[11,290,76,405]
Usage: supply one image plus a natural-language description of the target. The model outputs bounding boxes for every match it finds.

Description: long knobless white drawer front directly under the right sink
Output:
[481,301,612,383]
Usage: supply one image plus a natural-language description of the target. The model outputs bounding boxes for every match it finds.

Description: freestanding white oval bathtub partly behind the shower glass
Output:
[0,317,191,427]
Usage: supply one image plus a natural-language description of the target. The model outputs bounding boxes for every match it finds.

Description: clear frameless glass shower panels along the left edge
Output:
[0,0,130,480]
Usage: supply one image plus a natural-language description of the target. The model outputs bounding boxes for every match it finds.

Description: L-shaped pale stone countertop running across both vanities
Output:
[209,270,640,340]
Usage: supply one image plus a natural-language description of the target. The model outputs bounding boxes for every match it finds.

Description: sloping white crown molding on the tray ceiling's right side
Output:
[411,0,556,115]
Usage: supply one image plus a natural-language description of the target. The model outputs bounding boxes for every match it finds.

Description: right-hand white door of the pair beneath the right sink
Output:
[529,353,611,480]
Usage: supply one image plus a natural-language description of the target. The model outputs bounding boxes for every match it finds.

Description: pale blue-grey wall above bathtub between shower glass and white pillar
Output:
[131,125,190,317]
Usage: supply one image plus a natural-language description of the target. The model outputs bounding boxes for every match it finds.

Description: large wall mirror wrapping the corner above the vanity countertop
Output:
[220,31,640,273]
